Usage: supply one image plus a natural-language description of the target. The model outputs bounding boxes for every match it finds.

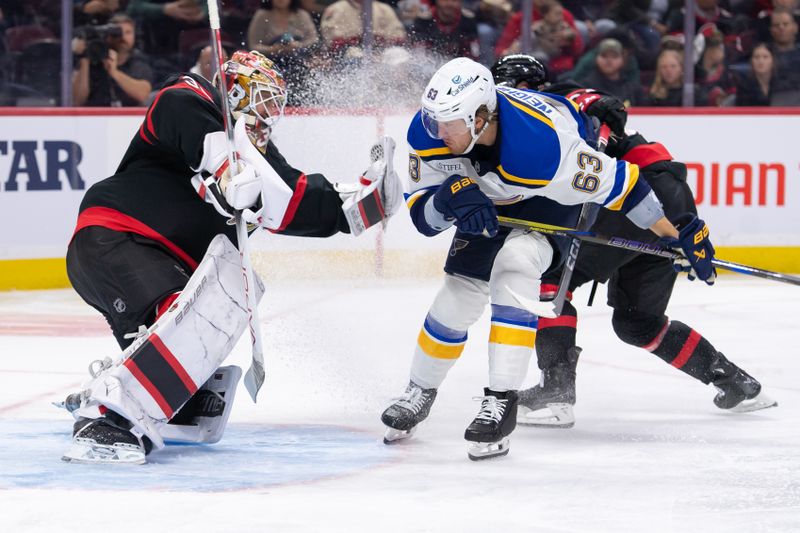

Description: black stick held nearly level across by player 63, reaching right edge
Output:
[497,217,800,285]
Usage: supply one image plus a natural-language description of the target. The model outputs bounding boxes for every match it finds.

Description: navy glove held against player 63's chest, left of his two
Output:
[433,175,500,237]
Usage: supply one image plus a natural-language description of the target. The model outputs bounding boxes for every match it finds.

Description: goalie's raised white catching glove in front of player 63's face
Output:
[334,137,403,236]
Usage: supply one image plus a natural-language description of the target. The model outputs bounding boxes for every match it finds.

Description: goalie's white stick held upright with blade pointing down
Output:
[207,0,266,402]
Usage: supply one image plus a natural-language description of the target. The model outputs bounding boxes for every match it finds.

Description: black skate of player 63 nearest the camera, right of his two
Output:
[464,388,518,461]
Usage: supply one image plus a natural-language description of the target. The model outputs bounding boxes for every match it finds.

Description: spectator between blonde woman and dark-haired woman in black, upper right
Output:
[695,26,736,107]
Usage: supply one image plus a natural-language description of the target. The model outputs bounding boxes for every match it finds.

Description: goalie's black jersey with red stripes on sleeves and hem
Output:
[75,74,350,271]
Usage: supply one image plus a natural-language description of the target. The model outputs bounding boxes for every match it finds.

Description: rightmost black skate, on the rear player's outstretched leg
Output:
[711,353,778,413]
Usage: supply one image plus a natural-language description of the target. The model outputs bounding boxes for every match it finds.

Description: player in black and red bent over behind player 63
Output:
[492,54,777,427]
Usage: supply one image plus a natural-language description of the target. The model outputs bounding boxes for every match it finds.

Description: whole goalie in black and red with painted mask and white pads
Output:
[65,51,402,462]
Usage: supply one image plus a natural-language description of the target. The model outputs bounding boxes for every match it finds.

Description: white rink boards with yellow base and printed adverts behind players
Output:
[0,108,800,289]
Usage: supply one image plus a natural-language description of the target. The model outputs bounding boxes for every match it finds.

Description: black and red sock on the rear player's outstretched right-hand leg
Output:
[644,320,717,384]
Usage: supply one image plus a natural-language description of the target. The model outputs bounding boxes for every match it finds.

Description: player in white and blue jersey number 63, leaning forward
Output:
[381,58,715,460]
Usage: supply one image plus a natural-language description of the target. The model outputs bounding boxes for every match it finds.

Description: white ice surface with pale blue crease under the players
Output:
[0,276,800,533]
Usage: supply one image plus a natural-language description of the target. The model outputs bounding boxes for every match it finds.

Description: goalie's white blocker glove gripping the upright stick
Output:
[192,117,292,229]
